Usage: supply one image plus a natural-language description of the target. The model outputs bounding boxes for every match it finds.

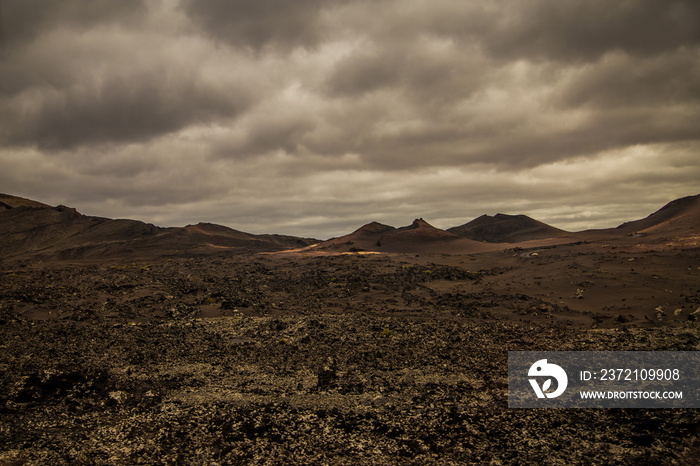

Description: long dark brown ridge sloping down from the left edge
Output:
[0,195,316,260]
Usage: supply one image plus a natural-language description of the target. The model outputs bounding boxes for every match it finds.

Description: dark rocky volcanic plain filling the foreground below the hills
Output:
[0,192,700,465]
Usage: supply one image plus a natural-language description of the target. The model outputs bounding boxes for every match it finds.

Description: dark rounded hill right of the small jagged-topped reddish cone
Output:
[447,214,569,243]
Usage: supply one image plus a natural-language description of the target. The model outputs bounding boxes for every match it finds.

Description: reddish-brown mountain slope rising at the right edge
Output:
[615,194,700,234]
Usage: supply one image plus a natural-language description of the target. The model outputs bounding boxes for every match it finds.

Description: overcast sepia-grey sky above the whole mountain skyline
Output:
[0,0,700,239]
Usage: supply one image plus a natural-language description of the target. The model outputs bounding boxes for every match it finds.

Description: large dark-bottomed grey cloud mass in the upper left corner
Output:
[0,0,256,150]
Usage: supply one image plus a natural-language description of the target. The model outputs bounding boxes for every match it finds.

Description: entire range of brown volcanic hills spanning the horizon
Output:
[0,194,700,261]
